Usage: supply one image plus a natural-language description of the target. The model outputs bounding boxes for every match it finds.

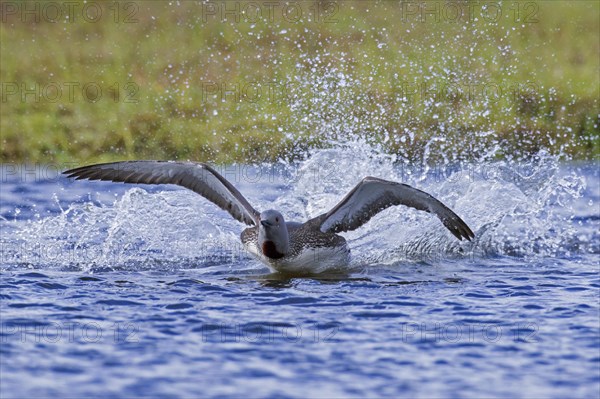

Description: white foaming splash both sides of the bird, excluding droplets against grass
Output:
[2,145,598,273]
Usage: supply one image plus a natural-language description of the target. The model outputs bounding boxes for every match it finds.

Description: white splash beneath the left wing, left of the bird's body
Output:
[3,188,248,271]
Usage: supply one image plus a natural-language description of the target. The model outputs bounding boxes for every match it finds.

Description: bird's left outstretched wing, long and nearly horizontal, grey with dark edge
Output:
[63,161,260,226]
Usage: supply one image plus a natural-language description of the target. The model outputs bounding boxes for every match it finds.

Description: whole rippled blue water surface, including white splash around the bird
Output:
[0,151,600,398]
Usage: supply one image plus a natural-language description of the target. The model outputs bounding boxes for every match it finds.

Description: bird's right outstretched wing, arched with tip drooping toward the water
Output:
[310,177,475,241]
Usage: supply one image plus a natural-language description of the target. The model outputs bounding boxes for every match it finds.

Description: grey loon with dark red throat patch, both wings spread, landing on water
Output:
[63,161,475,274]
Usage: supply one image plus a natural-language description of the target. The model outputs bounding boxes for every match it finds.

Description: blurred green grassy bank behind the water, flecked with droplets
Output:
[0,1,600,162]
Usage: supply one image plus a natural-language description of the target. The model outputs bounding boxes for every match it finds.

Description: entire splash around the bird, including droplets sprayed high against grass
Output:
[2,59,598,270]
